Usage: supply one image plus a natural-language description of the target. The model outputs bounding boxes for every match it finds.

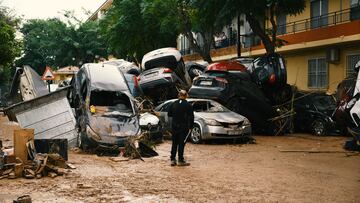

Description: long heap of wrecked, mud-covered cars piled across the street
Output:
[5,48,360,154]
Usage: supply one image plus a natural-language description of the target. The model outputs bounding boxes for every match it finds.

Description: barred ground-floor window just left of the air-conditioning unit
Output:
[308,58,328,89]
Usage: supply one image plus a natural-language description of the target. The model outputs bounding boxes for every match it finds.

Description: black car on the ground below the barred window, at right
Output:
[294,92,343,135]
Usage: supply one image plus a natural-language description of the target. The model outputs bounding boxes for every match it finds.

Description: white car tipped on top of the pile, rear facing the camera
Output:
[139,48,191,104]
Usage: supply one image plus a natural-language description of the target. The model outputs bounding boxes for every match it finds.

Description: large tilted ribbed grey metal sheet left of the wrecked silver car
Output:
[5,89,77,147]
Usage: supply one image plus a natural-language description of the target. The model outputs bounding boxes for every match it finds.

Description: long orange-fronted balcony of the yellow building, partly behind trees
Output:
[181,6,360,56]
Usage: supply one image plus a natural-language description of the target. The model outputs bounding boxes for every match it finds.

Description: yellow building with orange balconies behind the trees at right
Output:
[183,0,360,93]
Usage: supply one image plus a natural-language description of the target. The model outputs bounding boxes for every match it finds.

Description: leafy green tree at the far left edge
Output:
[0,6,21,85]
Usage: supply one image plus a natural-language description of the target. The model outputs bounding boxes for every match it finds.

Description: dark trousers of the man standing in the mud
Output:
[170,128,189,161]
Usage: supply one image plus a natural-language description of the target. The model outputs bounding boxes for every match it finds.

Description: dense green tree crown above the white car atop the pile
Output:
[100,0,178,61]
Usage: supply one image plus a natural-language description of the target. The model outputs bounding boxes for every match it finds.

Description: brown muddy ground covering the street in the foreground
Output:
[0,114,360,202]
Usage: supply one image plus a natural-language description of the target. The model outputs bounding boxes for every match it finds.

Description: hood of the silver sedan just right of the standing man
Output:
[194,111,245,123]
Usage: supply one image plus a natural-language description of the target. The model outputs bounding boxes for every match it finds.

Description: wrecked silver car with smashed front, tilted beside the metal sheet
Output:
[69,63,140,150]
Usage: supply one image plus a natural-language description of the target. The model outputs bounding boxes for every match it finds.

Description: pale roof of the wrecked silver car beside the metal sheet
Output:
[81,63,129,91]
